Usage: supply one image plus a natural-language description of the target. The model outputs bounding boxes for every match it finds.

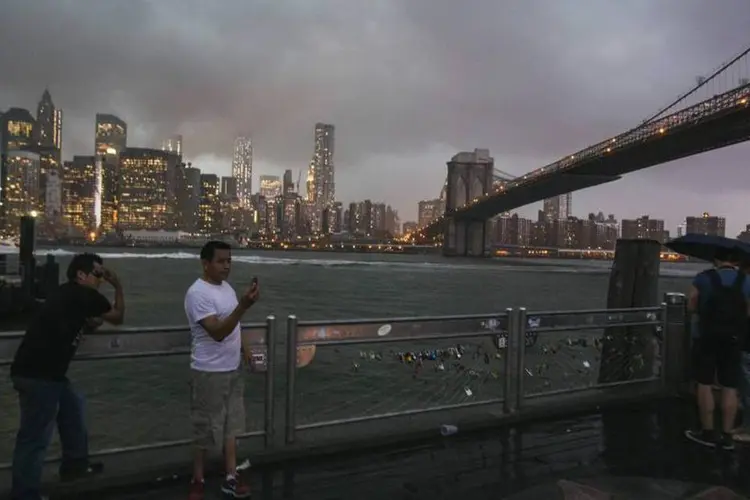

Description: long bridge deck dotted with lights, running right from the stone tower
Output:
[419,85,750,238]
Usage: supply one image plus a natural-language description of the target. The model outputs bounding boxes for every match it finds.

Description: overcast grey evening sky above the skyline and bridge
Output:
[0,0,750,234]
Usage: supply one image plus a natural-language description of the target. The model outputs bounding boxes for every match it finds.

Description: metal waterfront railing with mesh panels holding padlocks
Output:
[0,294,687,468]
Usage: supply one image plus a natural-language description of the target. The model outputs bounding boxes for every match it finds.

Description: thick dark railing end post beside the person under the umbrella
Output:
[661,293,690,391]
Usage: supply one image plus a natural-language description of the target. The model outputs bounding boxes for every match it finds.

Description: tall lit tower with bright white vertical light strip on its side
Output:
[94,113,128,233]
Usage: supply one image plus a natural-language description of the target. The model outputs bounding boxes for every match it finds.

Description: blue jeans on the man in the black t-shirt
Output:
[12,377,89,500]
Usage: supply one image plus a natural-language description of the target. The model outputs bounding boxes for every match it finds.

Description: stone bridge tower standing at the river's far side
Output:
[443,149,495,257]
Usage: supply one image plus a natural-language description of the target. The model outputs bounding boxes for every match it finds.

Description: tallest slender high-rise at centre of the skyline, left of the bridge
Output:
[307,123,336,231]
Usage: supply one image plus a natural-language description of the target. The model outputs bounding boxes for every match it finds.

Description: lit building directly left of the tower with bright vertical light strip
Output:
[62,156,96,236]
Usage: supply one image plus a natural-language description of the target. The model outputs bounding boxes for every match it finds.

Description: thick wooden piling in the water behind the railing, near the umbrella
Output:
[599,239,661,384]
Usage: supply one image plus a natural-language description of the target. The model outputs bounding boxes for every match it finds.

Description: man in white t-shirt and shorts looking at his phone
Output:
[185,241,260,500]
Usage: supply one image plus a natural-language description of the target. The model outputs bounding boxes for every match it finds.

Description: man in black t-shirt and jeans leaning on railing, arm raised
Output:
[10,253,125,500]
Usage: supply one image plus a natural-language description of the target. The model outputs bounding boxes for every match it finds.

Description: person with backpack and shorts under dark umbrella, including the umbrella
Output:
[667,235,750,450]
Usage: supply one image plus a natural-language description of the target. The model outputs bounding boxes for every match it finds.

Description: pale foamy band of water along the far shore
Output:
[0,246,696,278]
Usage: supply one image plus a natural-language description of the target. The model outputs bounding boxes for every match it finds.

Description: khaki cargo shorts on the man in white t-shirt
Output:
[190,370,245,450]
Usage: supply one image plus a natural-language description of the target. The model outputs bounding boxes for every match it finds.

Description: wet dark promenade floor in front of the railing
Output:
[4,398,750,500]
